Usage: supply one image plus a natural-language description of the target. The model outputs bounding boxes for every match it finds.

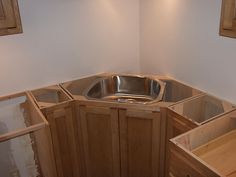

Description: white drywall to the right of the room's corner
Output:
[140,0,236,103]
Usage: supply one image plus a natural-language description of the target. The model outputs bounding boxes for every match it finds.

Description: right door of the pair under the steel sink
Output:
[119,109,161,177]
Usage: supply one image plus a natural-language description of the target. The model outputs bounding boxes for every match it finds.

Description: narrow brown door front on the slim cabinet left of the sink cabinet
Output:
[45,104,80,177]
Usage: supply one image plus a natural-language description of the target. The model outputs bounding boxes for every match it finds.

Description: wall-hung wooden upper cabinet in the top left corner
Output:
[0,0,22,35]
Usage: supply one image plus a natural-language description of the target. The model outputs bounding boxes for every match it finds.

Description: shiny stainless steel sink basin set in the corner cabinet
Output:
[84,75,165,104]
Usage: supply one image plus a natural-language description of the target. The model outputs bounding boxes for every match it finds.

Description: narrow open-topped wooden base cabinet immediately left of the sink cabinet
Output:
[31,86,80,177]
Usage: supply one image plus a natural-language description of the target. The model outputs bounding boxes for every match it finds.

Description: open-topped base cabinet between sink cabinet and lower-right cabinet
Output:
[166,95,235,177]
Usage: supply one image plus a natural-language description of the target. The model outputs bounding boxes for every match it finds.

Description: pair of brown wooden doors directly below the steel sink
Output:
[76,103,161,177]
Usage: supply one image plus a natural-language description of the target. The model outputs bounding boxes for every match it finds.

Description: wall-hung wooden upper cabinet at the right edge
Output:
[220,0,236,38]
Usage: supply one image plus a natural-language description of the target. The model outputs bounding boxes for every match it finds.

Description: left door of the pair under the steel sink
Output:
[79,106,120,177]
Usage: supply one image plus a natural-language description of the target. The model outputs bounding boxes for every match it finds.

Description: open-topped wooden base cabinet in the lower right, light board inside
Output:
[169,111,236,177]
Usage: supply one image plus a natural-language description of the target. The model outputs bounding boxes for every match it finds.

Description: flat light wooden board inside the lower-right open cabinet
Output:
[192,130,236,177]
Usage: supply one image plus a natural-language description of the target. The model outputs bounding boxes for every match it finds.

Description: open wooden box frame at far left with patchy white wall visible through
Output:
[0,92,56,177]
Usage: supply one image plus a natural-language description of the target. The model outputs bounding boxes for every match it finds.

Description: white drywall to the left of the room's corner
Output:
[0,0,139,95]
